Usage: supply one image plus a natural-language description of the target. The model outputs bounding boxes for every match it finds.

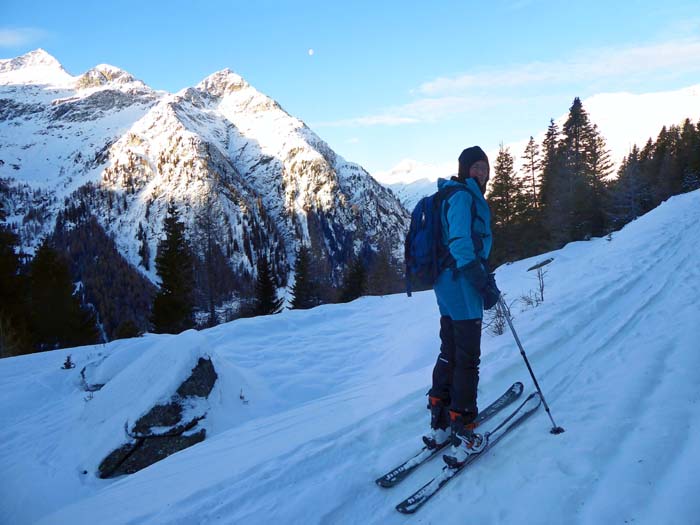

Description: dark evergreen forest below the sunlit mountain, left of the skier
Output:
[0,172,403,355]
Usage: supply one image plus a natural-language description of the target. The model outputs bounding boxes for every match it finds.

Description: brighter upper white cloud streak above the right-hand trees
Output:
[417,38,700,96]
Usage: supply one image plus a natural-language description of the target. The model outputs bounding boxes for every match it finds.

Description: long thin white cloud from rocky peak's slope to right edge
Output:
[314,37,700,127]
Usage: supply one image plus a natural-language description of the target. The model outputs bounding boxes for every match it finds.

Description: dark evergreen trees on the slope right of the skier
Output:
[488,98,700,266]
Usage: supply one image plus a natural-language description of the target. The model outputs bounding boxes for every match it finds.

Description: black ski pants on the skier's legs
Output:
[430,315,481,423]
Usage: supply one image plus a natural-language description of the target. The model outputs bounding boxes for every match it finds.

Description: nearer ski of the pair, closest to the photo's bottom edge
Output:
[396,392,542,514]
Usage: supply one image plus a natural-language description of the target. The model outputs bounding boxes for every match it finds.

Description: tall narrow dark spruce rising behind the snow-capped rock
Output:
[151,202,194,334]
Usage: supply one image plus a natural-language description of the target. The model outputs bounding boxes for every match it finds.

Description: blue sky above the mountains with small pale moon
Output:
[0,0,700,172]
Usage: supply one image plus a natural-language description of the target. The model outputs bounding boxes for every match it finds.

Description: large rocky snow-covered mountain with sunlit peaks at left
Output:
[0,50,406,282]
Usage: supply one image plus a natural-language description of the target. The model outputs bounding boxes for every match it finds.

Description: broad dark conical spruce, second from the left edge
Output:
[29,242,99,351]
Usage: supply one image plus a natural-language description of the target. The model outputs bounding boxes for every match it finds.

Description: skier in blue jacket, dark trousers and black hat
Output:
[423,146,500,463]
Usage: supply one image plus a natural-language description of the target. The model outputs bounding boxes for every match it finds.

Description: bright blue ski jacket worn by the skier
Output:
[433,179,493,321]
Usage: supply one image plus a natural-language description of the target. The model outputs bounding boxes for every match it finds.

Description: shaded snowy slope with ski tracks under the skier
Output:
[0,187,700,525]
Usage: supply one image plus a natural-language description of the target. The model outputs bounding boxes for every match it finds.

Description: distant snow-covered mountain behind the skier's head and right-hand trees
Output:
[380,84,700,210]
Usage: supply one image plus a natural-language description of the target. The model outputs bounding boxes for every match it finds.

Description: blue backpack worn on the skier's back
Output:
[404,186,476,297]
